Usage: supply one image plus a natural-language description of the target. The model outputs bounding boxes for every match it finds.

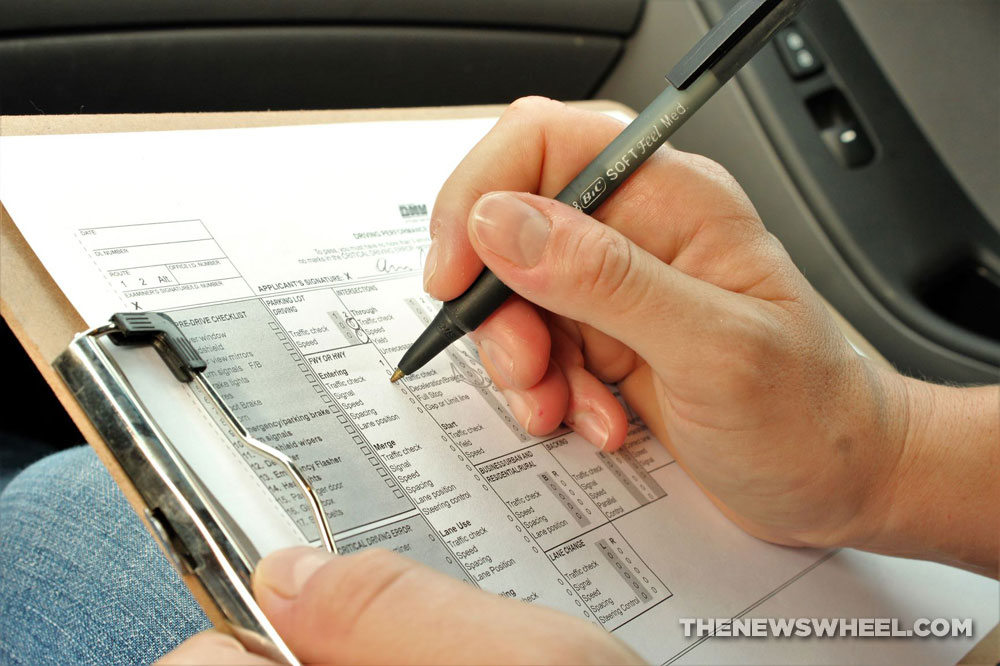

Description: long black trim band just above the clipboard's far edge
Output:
[0,26,622,115]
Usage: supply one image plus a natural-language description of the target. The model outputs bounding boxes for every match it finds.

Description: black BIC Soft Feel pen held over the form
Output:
[390,0,808,382]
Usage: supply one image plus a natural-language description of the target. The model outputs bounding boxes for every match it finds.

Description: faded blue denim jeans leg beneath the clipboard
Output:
[0,446,210,665]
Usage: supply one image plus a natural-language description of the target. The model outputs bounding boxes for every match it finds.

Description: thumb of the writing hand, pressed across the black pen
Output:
[469,192,723,367]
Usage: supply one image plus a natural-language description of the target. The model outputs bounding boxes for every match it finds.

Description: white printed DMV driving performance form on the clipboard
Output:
[0,119,998,664]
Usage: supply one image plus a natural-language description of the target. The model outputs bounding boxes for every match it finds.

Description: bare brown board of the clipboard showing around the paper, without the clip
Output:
[0,106,1000,664]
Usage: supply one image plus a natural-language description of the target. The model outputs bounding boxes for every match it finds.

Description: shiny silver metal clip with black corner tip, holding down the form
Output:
[53,312,337,664]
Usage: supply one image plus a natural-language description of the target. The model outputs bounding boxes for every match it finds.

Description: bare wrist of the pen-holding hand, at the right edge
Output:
[843,371,1000,576]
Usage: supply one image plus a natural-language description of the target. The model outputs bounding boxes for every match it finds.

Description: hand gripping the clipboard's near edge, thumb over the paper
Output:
[157,547,642,666]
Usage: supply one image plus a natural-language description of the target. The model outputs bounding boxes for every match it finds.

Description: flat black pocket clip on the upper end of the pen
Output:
[666,0,780,90]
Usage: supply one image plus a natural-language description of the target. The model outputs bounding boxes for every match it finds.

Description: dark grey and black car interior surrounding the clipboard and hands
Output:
[0,0,1000,477]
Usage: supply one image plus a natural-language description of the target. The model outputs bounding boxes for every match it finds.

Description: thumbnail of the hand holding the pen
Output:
[471,192,551,268]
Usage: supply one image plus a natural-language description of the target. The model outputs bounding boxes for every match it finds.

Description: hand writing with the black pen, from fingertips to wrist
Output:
[425,94,905,545]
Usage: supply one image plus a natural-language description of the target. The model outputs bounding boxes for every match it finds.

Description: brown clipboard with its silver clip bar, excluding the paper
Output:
[0,101,968,663]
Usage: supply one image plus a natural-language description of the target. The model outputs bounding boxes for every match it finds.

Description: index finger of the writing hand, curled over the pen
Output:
[424,97,623,301]
